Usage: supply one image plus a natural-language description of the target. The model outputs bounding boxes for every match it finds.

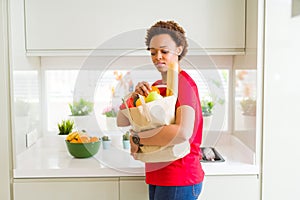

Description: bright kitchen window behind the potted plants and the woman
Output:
[43,69,229,134]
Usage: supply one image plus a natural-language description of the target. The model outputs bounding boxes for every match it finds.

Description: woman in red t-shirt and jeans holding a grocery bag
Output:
[118,21,204,200]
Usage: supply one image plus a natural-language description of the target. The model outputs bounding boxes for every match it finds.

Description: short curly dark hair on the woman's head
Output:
[145,21,188,60]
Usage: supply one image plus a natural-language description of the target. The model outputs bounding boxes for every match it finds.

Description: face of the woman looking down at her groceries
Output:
[149,34,182,72]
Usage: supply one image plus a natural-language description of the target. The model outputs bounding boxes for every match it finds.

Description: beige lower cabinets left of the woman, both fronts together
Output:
[13,177,148,200]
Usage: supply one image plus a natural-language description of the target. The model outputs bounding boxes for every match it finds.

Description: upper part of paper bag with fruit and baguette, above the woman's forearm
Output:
[120,63,179,132]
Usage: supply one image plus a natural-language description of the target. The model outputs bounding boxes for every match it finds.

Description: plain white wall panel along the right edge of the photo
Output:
[262,0,300,200]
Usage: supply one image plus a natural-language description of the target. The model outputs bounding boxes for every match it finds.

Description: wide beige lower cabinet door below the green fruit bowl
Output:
[14,178,119,200]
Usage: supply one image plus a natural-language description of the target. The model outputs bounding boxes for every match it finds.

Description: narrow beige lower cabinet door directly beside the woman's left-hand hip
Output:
[120,177,149,200]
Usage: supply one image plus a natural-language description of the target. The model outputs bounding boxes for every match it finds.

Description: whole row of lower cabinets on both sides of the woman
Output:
[13,175,260,200]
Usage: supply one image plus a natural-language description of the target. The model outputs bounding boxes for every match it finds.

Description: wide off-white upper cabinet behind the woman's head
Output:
[25,0,245,55]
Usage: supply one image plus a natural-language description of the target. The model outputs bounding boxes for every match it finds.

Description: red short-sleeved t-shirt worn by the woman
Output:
[145,71,204,186]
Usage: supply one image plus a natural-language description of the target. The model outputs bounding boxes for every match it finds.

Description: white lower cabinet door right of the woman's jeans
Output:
[198,175,260,200]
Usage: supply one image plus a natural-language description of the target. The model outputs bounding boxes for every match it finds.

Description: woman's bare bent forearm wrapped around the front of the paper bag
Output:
[138,105,195,146]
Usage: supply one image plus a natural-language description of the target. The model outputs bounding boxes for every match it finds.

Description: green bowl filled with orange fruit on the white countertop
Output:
[66,132,100,158]
